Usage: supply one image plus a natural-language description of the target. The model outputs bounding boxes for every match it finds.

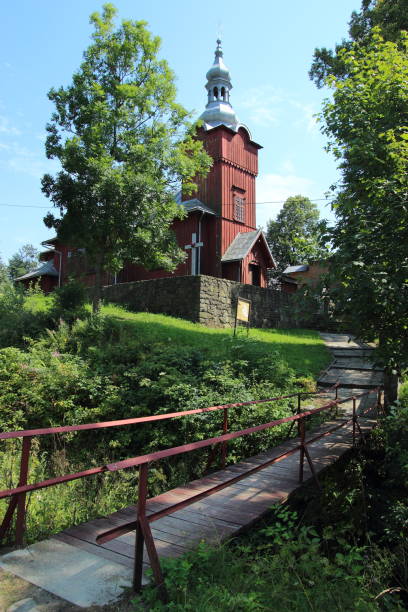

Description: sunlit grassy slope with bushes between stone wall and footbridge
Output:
[0,285,328,541]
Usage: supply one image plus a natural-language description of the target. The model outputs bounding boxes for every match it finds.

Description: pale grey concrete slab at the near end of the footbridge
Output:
[0,538,132,608]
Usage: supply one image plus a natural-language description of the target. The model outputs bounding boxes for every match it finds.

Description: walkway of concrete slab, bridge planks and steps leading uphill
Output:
[0,334,382,607]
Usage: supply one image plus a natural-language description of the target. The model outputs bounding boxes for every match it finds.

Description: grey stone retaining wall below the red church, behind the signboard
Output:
[103,275,293,327]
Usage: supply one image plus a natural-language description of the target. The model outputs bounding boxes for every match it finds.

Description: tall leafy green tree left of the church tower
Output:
[42,4,211,310]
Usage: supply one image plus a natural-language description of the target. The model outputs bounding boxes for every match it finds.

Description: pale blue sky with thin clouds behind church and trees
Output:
[0,0,360,261]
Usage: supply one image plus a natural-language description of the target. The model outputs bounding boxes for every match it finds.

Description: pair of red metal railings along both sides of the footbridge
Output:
[0,385,381,590]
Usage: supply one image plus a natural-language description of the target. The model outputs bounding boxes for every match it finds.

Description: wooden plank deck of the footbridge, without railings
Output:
[54,390,376,580]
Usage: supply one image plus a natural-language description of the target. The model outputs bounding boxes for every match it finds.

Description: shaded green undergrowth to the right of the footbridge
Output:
[134,406,408,612]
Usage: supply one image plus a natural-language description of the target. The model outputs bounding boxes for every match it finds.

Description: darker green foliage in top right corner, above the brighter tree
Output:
[309,0,408,87]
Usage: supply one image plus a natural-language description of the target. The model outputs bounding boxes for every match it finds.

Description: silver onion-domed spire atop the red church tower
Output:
[200,39,240,131]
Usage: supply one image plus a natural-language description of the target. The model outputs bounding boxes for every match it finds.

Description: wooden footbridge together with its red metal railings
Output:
[0,339,382,605]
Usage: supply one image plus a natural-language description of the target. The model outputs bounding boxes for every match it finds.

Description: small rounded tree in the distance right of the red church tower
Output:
[266,195,328,272]
